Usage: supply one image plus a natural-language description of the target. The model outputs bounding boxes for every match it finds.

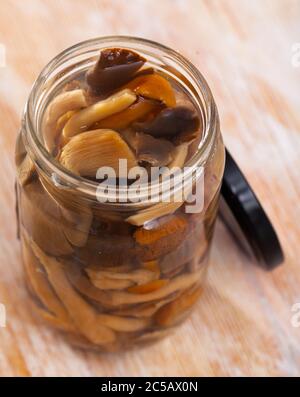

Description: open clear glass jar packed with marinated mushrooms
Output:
[16,36,225,351]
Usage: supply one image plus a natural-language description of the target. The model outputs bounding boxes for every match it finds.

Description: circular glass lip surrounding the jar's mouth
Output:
[22,36,218,207]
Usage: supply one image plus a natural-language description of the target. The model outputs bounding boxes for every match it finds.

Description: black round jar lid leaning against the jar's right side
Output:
[220,150,284,270]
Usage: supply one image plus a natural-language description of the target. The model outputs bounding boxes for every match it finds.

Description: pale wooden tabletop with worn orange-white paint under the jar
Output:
[0,0,300,376]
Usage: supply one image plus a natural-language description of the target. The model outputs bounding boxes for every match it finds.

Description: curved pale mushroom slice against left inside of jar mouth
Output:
[43,89,87,152]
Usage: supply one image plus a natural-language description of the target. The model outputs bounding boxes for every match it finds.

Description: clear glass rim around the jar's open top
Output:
[22,35,219,206]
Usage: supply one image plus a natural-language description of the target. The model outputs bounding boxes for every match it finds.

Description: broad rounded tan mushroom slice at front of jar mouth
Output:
[59,129,137,178]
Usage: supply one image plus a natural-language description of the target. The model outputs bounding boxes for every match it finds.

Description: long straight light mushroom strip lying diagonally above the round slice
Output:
[63,89,136,138]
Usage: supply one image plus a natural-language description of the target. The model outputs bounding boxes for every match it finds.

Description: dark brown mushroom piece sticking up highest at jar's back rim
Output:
[86,48,145,95]
